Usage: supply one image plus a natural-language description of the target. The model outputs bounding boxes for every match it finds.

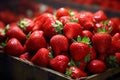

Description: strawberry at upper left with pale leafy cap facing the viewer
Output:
[18,18,34,34]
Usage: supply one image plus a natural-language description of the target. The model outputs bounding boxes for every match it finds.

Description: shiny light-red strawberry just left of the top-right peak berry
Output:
[73,12,94,30]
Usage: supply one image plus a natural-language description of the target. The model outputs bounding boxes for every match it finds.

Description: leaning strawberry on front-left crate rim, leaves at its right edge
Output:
[31,48,50,67]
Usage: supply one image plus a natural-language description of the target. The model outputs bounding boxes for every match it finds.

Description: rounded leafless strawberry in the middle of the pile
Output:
[50,34,69,55]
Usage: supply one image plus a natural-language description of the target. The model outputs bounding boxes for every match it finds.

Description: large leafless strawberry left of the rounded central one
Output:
[24,31,47,52]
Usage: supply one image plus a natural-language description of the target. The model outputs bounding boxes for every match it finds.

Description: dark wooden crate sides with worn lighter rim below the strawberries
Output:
[0,53,120,80]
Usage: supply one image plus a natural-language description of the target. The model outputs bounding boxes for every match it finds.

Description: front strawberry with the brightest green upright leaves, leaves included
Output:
[70,36,90,61]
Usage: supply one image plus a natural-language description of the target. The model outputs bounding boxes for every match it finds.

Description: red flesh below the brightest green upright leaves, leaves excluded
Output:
[70,42,90,61]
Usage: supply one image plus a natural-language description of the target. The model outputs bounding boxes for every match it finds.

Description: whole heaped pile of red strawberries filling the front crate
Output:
[0,8,120,79]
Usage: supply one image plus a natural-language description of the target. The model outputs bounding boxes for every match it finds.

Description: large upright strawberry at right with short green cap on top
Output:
[92,28,112,54]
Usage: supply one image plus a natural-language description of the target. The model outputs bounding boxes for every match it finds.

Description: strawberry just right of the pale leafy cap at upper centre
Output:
[63,22,82,39]
